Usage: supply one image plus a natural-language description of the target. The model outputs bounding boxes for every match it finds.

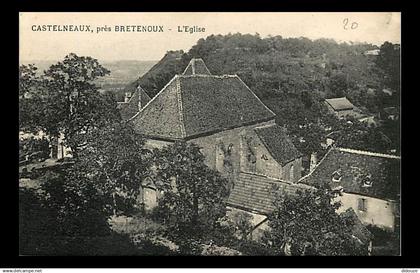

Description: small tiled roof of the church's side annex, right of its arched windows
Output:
[254,124,302,165]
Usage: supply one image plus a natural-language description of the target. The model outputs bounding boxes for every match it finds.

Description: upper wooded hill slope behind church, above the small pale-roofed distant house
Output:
[125,34,396,112]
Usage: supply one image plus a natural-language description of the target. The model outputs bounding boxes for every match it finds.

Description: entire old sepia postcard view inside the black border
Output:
[17,12,404,255]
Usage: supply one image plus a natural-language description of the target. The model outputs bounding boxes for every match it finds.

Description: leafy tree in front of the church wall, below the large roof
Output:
[154,142,229,241]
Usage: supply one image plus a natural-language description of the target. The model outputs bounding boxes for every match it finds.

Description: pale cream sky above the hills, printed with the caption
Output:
[19,12,401,62]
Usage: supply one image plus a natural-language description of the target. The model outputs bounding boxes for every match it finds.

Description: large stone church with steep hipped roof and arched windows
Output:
[121,59,302,209]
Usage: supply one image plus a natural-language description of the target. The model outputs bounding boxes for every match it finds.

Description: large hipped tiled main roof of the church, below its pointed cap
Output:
[131,61,275,140]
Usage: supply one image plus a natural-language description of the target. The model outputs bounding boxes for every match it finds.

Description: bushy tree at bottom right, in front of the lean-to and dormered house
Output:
[267,185,364,256]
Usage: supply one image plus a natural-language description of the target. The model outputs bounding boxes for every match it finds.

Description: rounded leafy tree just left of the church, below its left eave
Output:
[76,122,150,214]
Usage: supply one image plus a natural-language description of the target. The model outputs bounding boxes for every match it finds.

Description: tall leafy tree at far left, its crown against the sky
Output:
[19,53,119,156]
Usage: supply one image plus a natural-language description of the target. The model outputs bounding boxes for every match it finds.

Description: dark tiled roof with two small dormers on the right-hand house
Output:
[300,148,400,200]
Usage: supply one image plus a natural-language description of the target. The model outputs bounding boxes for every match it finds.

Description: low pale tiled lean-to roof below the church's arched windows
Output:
[228,173,312,215]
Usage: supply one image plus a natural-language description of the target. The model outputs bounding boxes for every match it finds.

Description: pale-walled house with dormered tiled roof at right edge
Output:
[299,147,400,231]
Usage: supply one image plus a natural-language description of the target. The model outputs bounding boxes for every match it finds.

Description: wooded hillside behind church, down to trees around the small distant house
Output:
[124,34,399,154]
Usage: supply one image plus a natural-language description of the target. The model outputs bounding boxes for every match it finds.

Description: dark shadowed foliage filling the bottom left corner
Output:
[19,188,166,256]
